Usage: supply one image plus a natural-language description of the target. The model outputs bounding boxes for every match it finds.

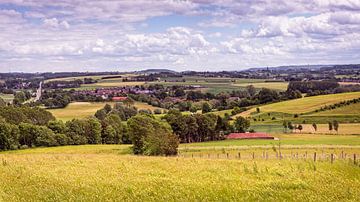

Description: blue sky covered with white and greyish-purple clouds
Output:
[0,0,360,72]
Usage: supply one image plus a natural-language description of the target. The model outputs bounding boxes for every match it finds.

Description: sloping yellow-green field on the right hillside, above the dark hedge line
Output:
[255,92,360,114]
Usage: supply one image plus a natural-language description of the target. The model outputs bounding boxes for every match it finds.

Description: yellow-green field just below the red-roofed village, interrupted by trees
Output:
[48,102,165,121]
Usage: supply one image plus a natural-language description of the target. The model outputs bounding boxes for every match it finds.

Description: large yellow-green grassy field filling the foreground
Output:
[0,145,360,201]
